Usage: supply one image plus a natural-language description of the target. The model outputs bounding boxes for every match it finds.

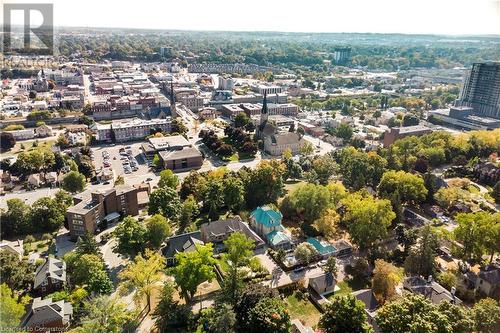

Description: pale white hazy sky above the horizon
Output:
[0,0,500,35]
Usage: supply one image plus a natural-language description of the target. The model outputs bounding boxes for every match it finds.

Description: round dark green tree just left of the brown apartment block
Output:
[31,197,66,232]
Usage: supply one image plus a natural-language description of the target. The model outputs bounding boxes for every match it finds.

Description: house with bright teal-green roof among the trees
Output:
[250,206,292,249]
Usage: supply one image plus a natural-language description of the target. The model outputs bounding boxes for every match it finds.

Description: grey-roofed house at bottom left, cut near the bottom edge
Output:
[21,297,73,332]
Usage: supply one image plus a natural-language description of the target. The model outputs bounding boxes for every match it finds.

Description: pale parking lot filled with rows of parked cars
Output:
[92,142,155,183]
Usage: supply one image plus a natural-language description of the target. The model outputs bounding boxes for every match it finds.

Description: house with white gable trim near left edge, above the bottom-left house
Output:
[33,257,66,296]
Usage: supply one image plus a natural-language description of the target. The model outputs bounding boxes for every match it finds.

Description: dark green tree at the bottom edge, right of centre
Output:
[318,295,373,333]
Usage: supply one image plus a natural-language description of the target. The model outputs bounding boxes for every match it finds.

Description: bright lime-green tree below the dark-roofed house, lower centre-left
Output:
[172,243,215,299]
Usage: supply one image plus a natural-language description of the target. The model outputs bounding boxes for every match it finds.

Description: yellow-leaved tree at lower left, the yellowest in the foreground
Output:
[119,250,165,311]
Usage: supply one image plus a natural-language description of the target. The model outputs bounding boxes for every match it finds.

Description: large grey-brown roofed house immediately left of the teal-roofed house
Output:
[200,216,264,252]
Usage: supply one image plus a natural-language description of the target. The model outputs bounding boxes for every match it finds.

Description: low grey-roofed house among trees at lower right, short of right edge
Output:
[403,276,462,304]
